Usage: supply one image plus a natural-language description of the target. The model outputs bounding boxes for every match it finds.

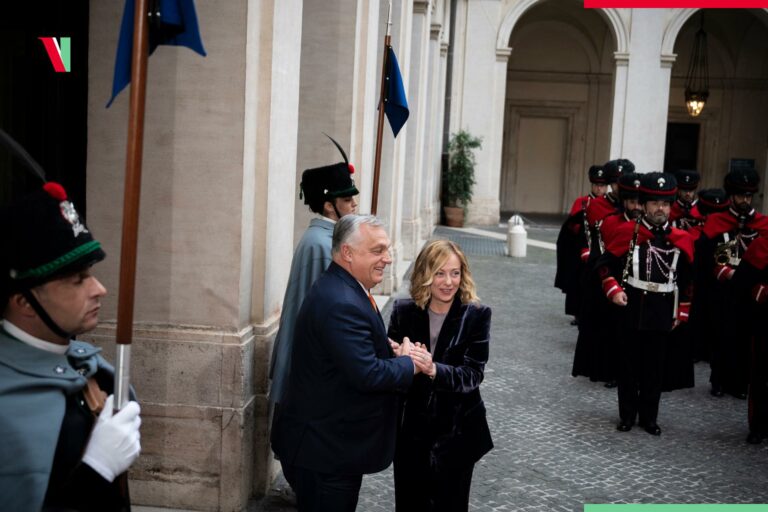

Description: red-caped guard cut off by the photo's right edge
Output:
[732,237,768,444]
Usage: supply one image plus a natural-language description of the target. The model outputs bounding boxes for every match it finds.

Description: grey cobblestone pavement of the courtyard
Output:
[252,222,768,512]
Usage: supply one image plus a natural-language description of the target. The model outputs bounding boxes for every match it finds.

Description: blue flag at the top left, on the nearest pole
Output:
[107,0,206,108]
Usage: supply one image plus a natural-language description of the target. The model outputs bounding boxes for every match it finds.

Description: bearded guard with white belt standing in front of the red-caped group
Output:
[596,172,693,435]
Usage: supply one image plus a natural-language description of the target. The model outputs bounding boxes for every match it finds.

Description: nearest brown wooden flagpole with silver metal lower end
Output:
[115,0,149,409]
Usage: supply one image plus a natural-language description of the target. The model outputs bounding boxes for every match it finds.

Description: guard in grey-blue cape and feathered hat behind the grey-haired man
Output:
[269,137,359,403]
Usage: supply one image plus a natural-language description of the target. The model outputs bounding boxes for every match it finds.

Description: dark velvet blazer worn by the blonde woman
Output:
[388,295,493,471]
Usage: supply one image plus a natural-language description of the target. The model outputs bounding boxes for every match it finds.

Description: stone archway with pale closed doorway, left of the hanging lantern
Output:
[497,0,628,214]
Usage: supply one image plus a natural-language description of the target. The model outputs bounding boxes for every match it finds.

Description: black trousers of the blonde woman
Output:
[395,446,475,512]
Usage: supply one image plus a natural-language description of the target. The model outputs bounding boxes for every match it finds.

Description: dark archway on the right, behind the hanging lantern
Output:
[662,9,768,208]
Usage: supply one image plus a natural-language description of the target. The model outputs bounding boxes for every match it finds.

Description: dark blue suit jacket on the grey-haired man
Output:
[272,263,413,474]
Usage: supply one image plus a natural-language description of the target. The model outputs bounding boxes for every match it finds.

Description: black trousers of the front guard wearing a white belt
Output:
[618,329,669,425]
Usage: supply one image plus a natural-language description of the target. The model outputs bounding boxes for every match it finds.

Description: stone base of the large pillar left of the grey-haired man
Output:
[82,320,277,511]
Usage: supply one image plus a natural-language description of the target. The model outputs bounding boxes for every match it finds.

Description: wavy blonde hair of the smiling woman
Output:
[411,240,480,309]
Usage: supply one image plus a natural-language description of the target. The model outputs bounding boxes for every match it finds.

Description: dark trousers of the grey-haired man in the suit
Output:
[281,461,363,512]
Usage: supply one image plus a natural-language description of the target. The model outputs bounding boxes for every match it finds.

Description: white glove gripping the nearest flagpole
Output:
[83,395,141,482]
